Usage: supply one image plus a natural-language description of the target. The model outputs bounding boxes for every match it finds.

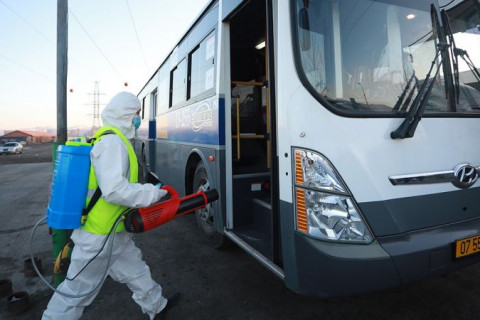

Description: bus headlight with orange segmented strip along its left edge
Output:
[294,149,373,243]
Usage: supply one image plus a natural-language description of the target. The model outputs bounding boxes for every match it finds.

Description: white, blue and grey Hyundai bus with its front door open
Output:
[135,0,480,297]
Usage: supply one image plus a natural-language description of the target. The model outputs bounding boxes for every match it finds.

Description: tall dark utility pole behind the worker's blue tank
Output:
[51,0,72,287]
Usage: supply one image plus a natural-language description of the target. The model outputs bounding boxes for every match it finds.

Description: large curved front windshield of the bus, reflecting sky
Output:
[293,0,480,116]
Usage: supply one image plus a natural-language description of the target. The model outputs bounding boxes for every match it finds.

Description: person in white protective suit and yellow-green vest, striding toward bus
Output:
[42,92,177,320]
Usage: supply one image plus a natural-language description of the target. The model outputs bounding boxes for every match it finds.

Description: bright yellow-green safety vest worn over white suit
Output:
[82,127,138,235]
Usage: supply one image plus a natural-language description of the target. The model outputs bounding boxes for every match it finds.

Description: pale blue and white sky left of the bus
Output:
[0,0,209,133]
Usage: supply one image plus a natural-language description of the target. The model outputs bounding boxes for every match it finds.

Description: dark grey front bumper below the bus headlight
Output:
[284,218,480,297]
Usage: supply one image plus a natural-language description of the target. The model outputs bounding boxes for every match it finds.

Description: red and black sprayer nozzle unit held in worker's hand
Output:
[124,186,218,233]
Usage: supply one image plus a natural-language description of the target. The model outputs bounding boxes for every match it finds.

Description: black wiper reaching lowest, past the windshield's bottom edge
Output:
[390,43,448,139]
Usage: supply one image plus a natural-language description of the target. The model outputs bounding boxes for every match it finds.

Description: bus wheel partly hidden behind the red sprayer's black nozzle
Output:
[193,162,228,249]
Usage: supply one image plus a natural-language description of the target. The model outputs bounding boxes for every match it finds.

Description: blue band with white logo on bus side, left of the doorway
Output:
[157,97,225,146]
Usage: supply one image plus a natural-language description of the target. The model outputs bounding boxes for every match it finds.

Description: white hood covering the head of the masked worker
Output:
[102,91,141,139]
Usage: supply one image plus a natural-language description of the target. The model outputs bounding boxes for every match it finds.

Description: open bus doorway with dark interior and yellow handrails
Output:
[230,1,278,261]
